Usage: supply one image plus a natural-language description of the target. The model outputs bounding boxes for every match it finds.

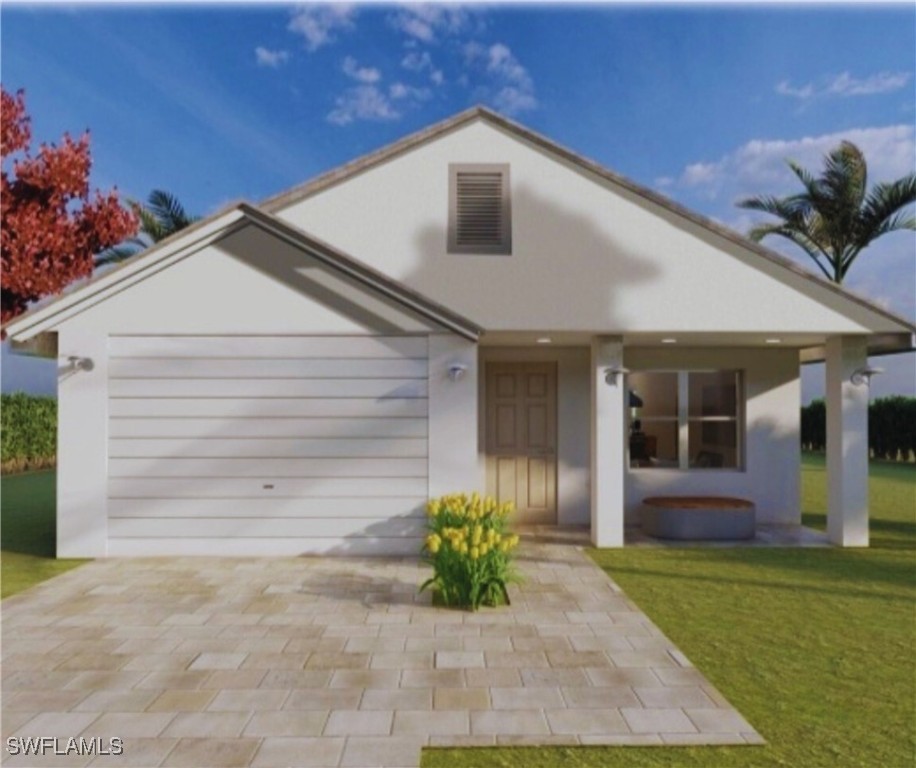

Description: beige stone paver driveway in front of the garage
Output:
[2,540,762,766]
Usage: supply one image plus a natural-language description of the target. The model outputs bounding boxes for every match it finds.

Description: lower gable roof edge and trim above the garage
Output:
[3,202,483,341]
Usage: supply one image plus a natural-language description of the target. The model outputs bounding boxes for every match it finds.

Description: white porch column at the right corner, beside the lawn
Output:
[826,336,868,547]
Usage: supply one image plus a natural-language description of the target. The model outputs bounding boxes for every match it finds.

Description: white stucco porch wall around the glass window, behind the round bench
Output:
[625,348,801,525]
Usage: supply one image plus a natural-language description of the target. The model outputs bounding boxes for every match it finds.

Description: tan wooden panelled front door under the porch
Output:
[486,363,557,524]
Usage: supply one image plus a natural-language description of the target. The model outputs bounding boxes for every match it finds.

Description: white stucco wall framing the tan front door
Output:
[476,347,591,525]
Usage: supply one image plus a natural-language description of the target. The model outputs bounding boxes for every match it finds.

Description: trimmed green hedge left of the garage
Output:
[0,392,57,473]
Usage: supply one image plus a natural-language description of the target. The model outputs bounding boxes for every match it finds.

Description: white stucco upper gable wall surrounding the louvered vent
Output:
[277,121,892,333]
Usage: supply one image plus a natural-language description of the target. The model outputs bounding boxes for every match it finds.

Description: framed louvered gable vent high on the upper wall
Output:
[448,163,512,255]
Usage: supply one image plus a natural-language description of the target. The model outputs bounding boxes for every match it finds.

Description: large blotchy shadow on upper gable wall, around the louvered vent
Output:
[404,185,658,332]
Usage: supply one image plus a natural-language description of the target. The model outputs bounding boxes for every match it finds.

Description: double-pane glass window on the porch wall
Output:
[628,371,743,469]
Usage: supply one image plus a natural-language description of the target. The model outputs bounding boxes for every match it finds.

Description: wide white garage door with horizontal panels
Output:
[108,336,428,555]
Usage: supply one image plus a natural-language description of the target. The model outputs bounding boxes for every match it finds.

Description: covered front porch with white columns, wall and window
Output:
[478,332,900,547]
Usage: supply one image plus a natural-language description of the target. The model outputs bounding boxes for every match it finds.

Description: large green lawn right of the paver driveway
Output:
[423,456,916,768]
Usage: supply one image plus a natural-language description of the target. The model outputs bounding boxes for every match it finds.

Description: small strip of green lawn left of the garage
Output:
[0,470,86,597]
